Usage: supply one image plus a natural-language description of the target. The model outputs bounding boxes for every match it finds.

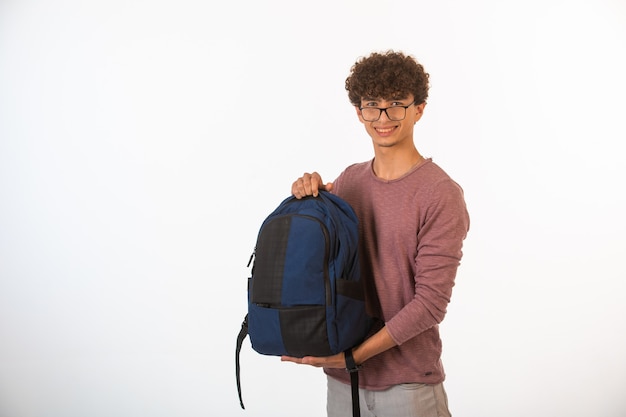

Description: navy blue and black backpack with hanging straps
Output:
[235,191,370,415]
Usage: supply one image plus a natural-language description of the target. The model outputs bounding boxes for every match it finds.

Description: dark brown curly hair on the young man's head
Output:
[346,50,429,106]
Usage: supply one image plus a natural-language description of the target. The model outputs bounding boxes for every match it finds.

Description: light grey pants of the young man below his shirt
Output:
[326,377,450,417]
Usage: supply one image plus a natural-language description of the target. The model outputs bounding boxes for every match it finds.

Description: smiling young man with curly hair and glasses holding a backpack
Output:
[282,51,469,417]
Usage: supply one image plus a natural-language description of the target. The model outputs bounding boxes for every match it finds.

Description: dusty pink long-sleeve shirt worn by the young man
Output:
[325,159,469,390]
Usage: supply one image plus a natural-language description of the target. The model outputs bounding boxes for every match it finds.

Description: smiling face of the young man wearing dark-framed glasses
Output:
[356,95,426,147]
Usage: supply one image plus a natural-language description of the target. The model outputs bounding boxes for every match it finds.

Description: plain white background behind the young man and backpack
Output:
[0,0,626,417]
